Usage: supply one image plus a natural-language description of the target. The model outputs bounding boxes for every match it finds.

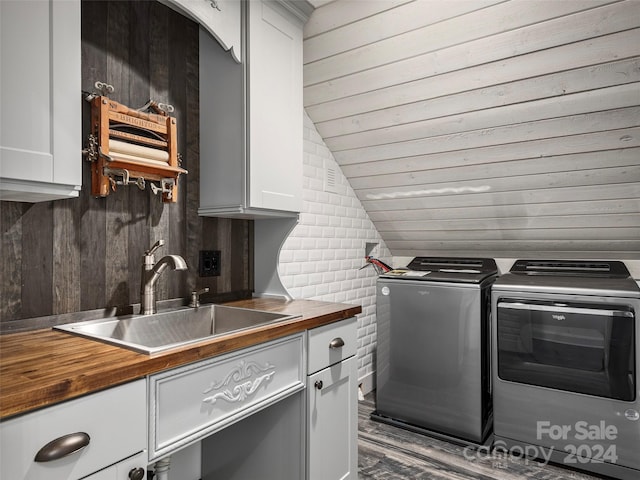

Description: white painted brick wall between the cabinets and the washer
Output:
[278,113,391,393]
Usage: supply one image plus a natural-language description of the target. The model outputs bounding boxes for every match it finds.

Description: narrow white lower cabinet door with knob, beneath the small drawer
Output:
[307,356,358,480]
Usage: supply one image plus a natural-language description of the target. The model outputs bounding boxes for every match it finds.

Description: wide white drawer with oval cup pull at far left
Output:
[0,380,147,480]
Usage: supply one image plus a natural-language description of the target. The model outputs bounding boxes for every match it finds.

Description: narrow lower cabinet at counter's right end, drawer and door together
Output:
[307,318,358,480]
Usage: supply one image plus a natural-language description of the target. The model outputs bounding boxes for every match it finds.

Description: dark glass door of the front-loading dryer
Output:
[497,298,636,401]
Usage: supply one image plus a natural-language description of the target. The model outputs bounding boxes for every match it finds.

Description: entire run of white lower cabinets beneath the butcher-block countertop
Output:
[0,318,358,480]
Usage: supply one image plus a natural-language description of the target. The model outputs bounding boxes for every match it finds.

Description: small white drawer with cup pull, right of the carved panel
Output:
[309,317,358,374]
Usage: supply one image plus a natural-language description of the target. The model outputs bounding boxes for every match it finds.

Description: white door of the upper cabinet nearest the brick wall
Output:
[247,1,303,212]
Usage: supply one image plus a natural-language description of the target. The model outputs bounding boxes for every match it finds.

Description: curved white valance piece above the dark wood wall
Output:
[167,0,242,63]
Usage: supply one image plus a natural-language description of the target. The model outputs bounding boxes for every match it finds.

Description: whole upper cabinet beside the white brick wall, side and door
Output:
[199,1,311,218]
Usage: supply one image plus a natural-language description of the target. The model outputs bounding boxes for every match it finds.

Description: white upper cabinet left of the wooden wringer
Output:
[0,0,82,202]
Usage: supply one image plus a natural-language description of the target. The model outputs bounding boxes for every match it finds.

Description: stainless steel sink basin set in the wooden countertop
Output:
[54,305,298,354]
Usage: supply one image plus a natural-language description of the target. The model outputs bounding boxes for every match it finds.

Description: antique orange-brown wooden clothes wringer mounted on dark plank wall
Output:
[86,96,187,203]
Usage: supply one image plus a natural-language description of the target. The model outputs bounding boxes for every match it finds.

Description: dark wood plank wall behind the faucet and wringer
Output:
[0,1,253,322]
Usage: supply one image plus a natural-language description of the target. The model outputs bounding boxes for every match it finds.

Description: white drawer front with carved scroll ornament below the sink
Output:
[149,333,306,461]
